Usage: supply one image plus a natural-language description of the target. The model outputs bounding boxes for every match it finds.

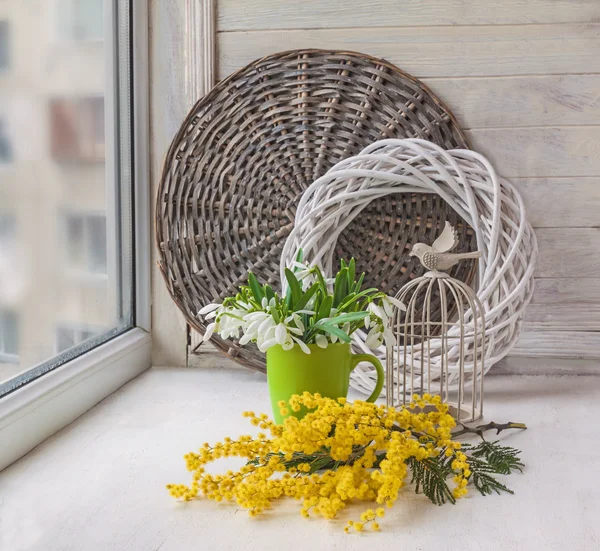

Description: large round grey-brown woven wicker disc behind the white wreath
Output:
[156,50,475,371]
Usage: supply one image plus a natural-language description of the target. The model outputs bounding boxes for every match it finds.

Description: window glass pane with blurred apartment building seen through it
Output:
[0,0,133,396]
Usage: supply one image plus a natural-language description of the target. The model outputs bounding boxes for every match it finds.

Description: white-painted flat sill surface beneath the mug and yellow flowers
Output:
[0,368,600,551]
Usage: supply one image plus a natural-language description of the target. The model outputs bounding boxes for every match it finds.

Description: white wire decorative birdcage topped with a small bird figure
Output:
[385,225,487,423]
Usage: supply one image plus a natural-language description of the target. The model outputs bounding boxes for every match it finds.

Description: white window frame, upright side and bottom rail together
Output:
[0,0,151,470]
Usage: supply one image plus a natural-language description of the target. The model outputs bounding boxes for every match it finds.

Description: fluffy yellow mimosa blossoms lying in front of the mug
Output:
[167,392,471,532]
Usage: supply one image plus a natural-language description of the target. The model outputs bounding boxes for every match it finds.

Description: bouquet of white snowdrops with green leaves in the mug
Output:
[199,252,405,354]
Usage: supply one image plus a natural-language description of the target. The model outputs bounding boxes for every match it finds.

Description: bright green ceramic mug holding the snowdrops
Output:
[267,343,384,424]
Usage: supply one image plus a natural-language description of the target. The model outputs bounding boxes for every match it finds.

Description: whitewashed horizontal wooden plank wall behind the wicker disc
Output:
[217,0,600,358]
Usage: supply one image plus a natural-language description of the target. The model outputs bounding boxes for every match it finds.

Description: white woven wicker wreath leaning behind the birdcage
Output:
[281,139,537,394]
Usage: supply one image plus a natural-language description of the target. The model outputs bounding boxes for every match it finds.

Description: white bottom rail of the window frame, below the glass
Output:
[0,328,151,470]
